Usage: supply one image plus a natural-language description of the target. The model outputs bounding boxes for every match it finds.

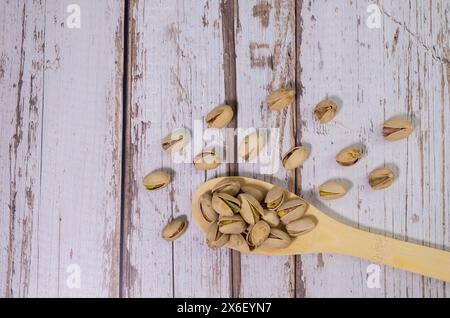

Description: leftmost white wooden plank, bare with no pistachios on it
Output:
[0,0,123,297]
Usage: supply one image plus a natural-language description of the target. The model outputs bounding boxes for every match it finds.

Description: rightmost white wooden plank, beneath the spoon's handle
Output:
[297,1,450,297]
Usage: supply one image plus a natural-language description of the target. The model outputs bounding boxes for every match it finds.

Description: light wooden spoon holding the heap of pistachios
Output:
[192,177,450,282]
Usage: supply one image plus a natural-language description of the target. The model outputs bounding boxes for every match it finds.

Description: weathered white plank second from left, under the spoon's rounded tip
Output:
[124,0,230,297]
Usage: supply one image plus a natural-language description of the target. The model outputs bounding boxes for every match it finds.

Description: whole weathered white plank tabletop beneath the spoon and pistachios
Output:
[0,0,450,297]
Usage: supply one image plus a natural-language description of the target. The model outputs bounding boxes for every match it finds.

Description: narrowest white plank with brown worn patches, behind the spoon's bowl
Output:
[235,0,295,297]
